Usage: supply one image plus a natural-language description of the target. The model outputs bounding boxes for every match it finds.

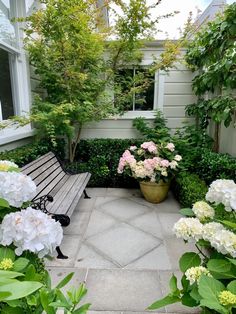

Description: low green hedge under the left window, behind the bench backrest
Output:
[0,140,65,167]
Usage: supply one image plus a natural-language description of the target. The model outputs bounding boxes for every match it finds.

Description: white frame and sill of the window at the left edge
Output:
[0,0,33,145]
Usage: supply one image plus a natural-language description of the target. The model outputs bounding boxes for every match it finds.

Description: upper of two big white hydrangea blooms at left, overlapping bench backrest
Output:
[0,171,36,207]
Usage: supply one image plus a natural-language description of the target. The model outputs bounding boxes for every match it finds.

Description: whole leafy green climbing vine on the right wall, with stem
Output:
[186,3,236,151]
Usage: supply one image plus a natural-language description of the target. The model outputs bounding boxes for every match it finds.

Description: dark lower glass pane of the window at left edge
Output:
[0,49,14,120]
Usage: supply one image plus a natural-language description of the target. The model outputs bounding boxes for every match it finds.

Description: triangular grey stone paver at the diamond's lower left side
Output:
[75,244,119,269]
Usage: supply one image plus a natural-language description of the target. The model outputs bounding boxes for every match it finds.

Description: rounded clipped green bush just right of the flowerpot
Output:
[172,172,208,207]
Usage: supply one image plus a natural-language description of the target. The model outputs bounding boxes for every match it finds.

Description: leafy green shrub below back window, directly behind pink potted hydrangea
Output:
[133,111,171,144]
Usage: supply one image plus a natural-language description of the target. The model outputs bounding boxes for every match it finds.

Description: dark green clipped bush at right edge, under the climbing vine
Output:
[195,149,236,184]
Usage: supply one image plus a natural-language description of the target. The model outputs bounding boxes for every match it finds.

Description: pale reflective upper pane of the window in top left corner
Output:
[0,0,16,47]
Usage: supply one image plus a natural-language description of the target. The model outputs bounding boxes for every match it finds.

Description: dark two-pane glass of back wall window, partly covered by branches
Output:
[114,67,156,111]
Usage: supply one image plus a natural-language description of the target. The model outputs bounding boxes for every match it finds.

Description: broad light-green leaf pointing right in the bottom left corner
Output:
[0,281,43,300]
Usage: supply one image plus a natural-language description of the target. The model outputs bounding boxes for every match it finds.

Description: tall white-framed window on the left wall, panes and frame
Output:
[0,0,32,145]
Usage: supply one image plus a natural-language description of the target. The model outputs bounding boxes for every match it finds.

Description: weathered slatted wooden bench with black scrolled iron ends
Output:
[22,152,91,258]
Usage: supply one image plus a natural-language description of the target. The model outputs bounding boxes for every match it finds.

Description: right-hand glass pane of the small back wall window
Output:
[135,69,155,110]
